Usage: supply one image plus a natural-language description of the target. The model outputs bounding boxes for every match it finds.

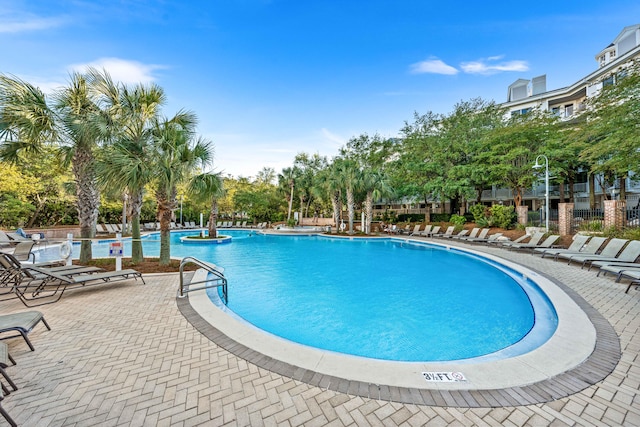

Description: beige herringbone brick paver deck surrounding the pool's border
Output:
[0,240,640,426]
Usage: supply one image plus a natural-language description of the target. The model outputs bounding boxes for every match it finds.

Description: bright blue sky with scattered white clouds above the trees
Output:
[0,0,640,177]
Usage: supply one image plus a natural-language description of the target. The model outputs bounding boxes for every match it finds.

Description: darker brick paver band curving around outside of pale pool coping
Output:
[178,254,621,407]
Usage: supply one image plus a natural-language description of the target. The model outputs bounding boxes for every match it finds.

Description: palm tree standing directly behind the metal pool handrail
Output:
[151,111,212,265]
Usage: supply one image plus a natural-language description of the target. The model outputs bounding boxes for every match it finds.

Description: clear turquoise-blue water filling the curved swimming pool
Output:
[76,230,557,361]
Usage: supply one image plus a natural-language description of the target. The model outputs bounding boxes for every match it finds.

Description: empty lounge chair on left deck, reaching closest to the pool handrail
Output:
[13,265,145,307]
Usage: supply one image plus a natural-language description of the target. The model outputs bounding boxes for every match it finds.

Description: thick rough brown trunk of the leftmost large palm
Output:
[72,146,100,263]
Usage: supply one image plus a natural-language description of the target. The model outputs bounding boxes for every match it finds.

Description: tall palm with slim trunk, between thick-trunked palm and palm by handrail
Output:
[89,70,166,264]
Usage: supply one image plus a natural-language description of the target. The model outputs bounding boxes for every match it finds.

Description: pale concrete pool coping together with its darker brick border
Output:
[178,239,621,407]
